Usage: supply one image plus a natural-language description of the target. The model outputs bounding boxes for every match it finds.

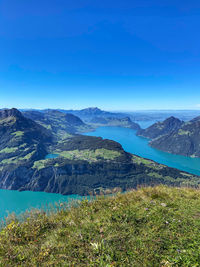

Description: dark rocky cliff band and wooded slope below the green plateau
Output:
[0,152,199,195]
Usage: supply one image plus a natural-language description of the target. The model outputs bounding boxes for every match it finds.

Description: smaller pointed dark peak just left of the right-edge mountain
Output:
[137,117,184,139]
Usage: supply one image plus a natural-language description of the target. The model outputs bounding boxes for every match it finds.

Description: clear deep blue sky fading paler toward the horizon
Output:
[0,0,200,110]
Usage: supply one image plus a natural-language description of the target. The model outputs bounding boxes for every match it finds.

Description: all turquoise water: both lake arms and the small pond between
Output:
[0,126,200,219]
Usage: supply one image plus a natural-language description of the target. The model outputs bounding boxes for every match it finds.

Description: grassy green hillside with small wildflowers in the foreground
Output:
[0,186,200,267]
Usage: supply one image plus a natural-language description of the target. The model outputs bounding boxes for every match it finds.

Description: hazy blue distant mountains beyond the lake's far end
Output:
[23,108,140,133]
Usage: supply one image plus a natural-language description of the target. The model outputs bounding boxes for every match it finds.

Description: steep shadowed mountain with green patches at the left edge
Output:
[0,109,53,164]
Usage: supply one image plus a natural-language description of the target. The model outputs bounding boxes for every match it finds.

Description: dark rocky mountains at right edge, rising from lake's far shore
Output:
[138,117,200,157]
